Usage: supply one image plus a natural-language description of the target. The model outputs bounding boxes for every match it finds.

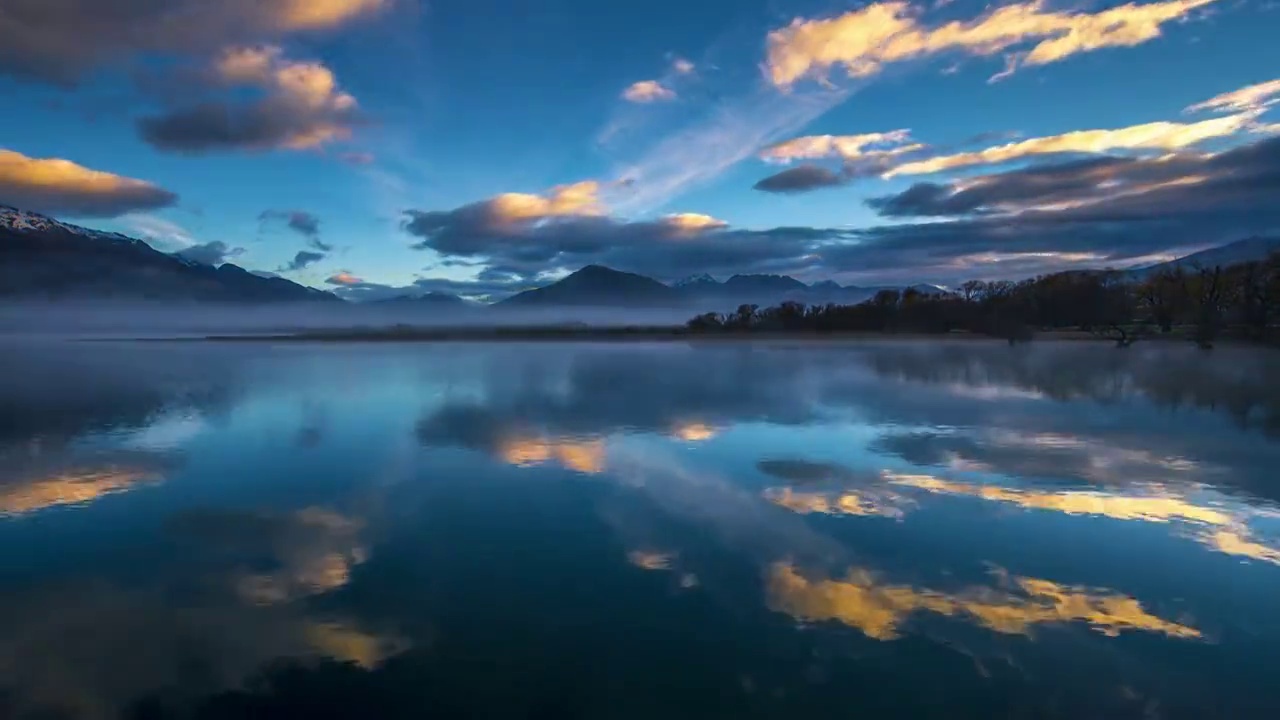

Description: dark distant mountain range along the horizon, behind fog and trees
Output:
[0,205,1280,313]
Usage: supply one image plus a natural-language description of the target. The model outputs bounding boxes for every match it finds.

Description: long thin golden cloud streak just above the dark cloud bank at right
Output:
[883,113,1254,178]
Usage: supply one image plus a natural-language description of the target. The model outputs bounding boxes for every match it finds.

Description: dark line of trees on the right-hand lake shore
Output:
[686,252,1280,348]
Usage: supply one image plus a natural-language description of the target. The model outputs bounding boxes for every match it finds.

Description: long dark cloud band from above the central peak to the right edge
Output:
[403,138,1280,284]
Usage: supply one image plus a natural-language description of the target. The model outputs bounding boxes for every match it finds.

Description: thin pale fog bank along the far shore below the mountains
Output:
[0,301,696,337]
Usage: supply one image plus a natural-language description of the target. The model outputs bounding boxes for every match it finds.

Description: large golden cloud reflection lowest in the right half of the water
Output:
[767,562,1201,641]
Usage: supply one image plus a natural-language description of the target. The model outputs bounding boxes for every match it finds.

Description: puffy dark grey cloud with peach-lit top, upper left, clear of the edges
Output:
[138,46,361,154]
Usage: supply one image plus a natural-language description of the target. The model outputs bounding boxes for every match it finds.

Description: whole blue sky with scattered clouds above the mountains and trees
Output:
[0,0,1280,299]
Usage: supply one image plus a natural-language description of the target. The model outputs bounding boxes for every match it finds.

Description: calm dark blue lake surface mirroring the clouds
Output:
[0,341,1280,720]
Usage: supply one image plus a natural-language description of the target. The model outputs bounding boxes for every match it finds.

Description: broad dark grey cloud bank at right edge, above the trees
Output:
[822,138,1280,283]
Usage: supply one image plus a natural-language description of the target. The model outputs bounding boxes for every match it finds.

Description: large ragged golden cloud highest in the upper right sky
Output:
[764,0,1215,88]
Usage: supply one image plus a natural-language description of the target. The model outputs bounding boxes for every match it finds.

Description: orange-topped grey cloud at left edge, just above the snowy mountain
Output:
[0,149,178,218]
